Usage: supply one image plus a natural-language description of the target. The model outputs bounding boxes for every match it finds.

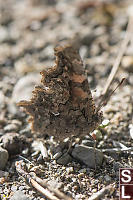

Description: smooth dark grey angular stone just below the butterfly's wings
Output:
[72,145,103,169]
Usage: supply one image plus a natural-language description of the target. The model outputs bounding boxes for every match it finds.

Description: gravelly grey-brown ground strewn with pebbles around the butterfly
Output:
[0,0,133,200]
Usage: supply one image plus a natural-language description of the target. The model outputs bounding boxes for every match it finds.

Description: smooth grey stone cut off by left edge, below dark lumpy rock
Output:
[0,147,8,170]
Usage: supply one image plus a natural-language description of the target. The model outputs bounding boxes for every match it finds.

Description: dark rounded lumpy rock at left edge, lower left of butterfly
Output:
[0,133,25,155]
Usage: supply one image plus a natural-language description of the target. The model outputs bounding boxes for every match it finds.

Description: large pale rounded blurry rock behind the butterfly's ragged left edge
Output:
[12,73,40,103]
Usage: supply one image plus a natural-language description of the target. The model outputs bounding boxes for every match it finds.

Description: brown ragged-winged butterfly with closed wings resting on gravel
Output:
[18,45,103,141]
